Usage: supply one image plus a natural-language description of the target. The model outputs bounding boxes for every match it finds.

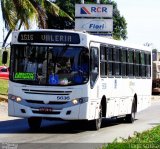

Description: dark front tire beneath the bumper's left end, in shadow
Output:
[28,117,42,131]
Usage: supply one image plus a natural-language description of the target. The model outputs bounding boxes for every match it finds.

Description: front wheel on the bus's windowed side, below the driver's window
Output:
[91,105,102,130]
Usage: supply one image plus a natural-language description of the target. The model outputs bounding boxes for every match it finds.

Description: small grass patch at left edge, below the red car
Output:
[0,79,8,95]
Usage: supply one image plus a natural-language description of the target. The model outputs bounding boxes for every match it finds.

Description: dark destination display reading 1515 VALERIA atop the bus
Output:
[18,31,80,44]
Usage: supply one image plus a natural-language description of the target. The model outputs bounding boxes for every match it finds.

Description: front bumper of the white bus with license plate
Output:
[8,99,88,120]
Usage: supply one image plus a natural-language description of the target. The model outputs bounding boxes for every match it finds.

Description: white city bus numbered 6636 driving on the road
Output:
[5,30,152,129]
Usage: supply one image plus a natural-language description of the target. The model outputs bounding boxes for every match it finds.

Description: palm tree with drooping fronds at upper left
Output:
[1,0,72,47]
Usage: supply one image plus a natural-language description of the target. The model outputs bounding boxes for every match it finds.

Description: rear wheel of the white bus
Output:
[125,99,137,123]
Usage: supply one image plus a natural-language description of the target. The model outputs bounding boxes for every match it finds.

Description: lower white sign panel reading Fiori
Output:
[75,19,113,32]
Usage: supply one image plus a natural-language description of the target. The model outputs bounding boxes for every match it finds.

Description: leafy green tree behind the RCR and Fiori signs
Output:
[55,0,127,40]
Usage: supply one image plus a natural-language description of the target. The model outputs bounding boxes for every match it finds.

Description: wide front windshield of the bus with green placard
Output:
[10,45,89,86]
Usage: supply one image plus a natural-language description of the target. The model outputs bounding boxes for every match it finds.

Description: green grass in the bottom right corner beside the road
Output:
[102,125,160,149]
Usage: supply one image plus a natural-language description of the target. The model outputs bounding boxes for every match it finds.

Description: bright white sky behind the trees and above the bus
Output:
[0,0,160,50]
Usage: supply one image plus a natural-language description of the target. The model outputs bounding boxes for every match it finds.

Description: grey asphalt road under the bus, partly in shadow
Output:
[0,100,160,149]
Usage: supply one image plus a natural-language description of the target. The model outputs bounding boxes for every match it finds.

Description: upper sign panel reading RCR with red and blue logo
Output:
[75,4,113,18]
